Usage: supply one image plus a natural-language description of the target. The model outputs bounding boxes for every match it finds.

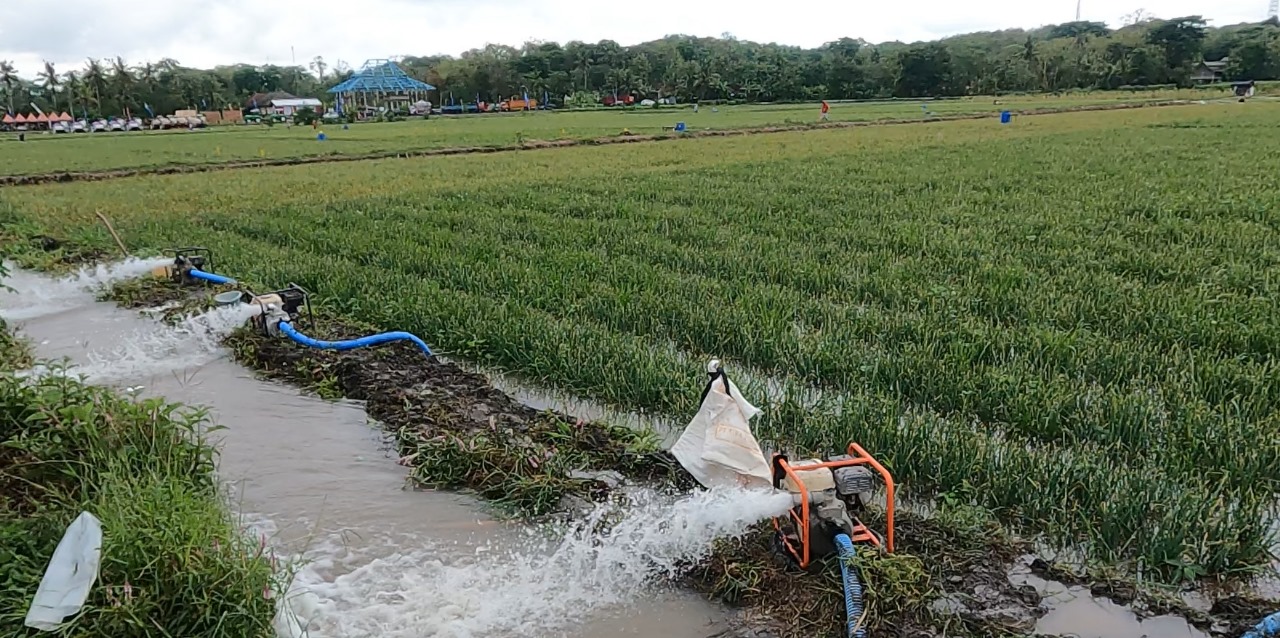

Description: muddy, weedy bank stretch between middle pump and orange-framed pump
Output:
[228,311,682,515]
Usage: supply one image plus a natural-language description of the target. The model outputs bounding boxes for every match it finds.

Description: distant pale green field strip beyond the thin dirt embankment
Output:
[0,92,1239,176]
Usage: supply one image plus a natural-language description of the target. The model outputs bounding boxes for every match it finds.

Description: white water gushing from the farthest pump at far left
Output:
[0,258,173,322]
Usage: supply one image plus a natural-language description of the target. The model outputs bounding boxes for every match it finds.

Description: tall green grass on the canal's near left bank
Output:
[0,265,287,638]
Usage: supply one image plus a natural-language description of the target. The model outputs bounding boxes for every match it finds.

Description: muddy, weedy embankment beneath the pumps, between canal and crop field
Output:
[94,267,1270,638]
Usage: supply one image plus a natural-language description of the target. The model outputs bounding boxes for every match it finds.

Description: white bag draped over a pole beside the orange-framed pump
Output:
[671,372,773,488]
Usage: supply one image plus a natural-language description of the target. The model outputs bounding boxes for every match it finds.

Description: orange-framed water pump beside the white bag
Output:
[772,443,893,569]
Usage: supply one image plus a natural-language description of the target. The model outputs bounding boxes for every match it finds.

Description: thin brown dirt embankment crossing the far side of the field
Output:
[0,100,1190,186]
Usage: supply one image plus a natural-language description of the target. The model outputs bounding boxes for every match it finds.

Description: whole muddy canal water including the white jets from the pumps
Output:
[0,261,790,638]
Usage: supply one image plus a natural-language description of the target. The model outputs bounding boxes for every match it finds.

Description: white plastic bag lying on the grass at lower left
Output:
[26,511,102,632]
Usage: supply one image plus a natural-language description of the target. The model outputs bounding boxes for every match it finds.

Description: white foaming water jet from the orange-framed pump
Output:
[276,488,792,638]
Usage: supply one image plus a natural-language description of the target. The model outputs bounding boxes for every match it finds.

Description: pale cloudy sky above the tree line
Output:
[0,0,1267,77]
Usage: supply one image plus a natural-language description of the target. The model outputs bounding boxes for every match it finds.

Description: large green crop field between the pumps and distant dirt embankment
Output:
[0,102,1280,579]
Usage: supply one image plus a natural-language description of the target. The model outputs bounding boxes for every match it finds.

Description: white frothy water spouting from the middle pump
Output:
[24,304,261,384]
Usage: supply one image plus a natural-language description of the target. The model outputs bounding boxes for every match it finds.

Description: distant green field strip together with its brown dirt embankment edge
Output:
[0,99,1187,186]
